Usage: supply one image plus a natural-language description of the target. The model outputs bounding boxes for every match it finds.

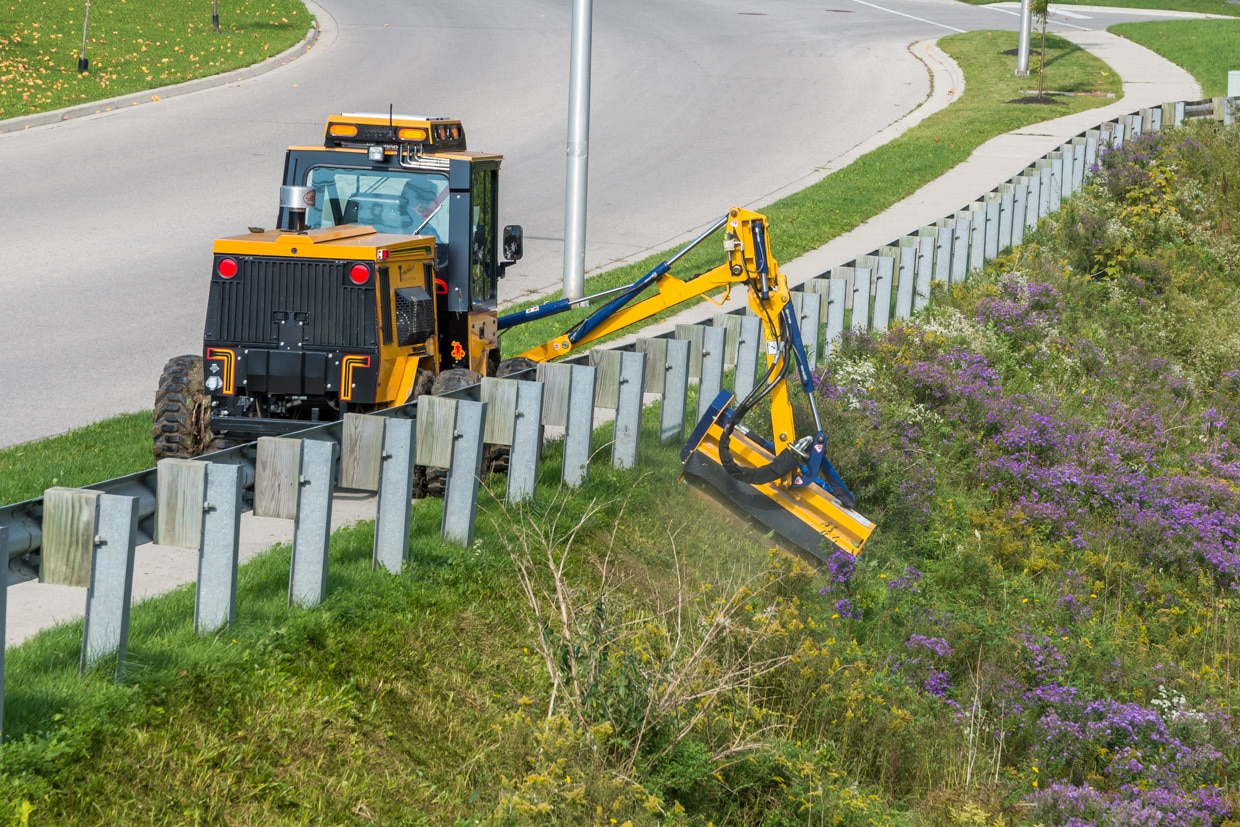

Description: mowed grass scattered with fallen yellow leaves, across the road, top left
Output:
[0,0,314,119]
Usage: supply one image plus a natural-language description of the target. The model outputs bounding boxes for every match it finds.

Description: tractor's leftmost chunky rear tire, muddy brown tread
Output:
[151,356,215,461]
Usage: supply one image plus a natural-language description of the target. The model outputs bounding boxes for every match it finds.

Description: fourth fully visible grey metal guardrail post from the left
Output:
[371,421,422,574]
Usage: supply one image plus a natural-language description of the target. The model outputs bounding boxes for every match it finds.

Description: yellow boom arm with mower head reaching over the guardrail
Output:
[498,208,873,554]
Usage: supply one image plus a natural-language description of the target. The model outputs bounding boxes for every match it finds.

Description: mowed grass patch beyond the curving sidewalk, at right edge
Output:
[1107,17,1240,98]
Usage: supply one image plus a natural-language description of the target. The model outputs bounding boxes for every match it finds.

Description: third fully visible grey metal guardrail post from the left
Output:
[289,439,339,609]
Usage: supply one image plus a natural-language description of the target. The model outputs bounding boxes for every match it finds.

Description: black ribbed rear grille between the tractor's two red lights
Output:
[206,258,378,350]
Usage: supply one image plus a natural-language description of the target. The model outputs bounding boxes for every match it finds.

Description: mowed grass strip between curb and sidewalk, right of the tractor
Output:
[503,31,1121,356]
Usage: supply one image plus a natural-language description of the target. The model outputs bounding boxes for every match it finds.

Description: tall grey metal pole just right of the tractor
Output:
[564,0,594,299]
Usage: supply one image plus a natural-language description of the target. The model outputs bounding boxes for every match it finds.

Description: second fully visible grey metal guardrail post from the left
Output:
[193,462,244,635]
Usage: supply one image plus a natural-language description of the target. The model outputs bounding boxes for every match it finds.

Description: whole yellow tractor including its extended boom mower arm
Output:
[154,114,873,553]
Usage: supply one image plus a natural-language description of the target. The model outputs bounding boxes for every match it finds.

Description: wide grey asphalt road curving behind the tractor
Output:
[0,0,1195,446]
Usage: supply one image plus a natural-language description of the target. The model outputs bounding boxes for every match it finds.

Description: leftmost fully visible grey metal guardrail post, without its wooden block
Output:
[79,493,138,681]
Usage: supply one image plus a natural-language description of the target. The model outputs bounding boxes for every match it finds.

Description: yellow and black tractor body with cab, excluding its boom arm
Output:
[154,114,522,459]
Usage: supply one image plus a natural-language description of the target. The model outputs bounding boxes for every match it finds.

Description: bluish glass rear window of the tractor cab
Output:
[306,166,448,244]
